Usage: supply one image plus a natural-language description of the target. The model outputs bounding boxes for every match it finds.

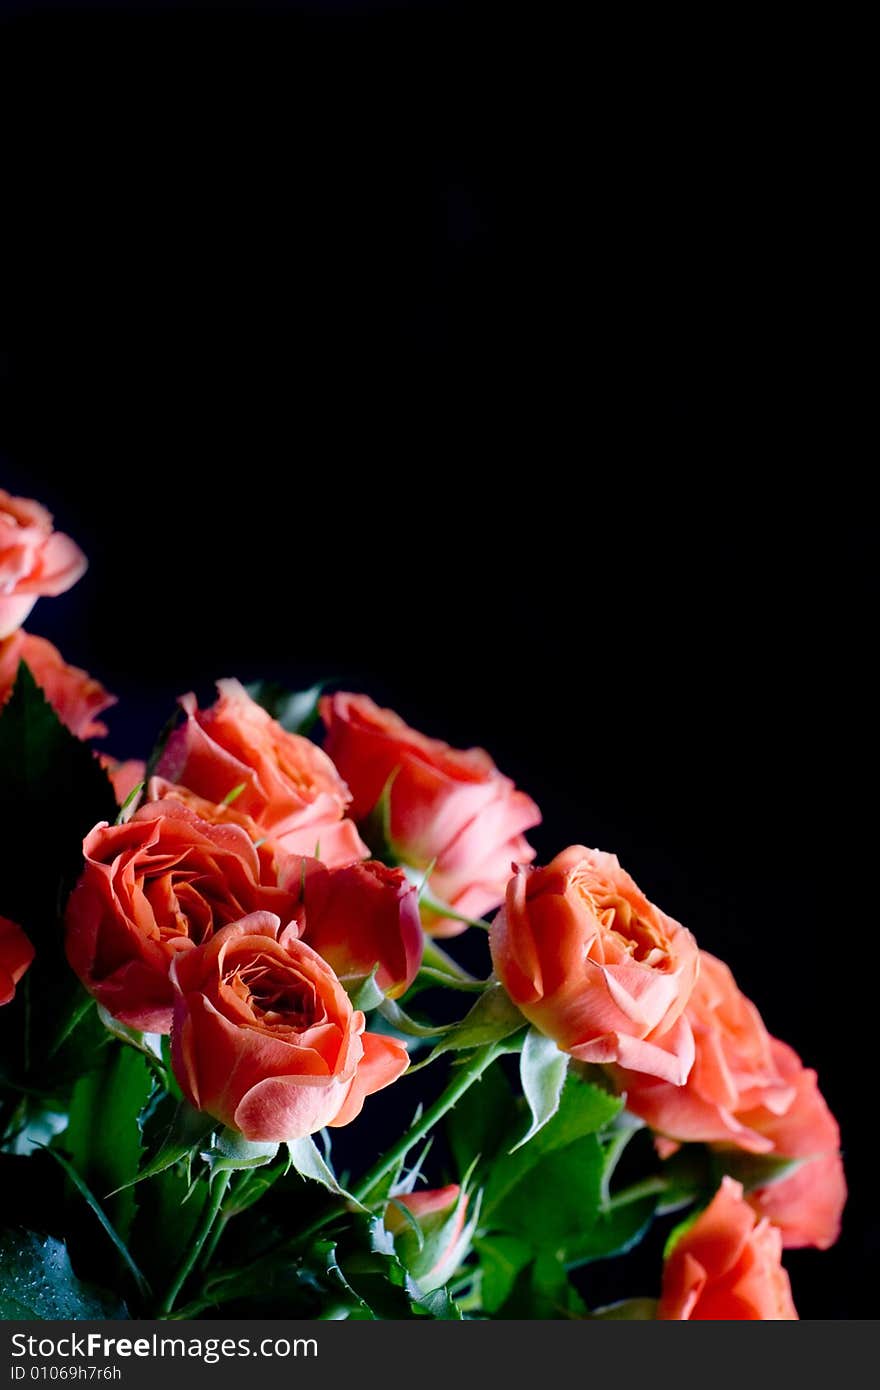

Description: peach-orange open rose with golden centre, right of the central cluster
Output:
[489,845,698,1086]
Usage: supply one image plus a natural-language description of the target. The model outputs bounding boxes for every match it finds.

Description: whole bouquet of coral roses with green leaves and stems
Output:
[0,492,845,1319]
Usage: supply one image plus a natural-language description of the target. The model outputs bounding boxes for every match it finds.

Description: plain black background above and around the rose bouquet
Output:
[0,4,879,1318]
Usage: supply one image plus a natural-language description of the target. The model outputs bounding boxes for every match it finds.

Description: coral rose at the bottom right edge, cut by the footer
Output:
[658,1177,798,1322]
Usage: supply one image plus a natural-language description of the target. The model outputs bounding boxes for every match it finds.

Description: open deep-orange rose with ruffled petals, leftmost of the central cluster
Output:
[65,801,299,1033]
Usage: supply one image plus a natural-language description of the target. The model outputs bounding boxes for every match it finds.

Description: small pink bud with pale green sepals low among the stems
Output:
[385,1183,473,1294]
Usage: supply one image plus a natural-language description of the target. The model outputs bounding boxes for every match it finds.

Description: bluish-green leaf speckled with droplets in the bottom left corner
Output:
[0,1230,128,1321]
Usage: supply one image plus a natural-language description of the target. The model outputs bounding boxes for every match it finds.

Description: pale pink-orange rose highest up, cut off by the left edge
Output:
[0,488,88,639]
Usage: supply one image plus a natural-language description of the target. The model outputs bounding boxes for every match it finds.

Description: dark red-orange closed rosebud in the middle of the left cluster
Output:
[302,859,424,998]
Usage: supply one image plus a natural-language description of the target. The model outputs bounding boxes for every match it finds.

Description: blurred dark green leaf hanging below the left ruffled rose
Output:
[62,1043,152,1241]
